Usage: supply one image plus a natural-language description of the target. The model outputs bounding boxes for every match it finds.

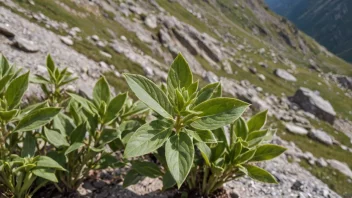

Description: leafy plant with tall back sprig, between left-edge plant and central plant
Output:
[36,56,147,192]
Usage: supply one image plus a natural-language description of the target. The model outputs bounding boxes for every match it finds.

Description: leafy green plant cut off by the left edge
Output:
[0,56,65,198]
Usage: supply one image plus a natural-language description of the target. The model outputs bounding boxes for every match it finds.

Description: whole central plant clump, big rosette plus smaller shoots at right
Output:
[124,54,285,195]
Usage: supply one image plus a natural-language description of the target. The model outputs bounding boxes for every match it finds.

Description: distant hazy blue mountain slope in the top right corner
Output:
[266,0,352,62]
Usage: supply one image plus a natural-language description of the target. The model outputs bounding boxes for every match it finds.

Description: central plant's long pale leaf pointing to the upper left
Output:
[124,74,173,119]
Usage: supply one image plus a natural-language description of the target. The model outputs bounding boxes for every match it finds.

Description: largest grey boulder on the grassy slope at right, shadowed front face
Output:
[291,87,336,124]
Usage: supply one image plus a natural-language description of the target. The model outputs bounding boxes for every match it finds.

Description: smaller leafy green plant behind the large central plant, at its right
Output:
[187,111,286,196]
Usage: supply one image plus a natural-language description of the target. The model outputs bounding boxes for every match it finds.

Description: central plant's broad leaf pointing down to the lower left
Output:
[124,120,173,158]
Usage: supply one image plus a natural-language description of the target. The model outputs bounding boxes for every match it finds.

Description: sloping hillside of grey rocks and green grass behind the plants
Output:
[0,0,352,197]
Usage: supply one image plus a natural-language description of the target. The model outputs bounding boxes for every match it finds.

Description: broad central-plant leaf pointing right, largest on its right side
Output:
[191,98,249,130]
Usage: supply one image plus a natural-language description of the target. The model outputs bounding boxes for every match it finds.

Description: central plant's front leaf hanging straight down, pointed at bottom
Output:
[165,132,194,188]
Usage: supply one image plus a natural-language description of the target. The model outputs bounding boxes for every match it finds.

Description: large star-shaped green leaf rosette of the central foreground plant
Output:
[124,54,249,188]
